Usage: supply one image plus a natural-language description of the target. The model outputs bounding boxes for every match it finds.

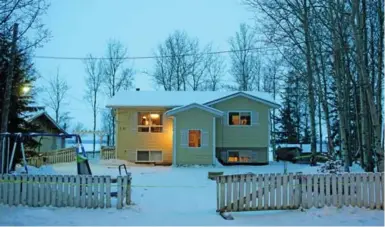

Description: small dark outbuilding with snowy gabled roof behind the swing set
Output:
[26,110,67,152]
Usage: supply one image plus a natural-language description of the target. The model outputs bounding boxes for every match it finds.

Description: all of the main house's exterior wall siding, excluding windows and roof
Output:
[112,94,270,164]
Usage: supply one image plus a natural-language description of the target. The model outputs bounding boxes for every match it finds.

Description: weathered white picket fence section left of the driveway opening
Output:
[0,175,131,209]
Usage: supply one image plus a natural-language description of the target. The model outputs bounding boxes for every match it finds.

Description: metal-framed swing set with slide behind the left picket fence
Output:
[0,133,92,175]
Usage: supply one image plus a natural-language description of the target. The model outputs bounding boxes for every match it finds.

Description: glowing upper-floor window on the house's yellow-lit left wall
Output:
[138,112,163,133]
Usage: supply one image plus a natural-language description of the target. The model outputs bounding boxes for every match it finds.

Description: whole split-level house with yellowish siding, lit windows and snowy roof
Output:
[107,90,279,165]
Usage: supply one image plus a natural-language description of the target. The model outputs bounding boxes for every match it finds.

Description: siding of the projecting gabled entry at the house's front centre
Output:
[175,108,214,165]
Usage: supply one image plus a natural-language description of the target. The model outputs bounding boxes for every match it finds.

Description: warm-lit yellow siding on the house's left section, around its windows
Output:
[116,108,173,164]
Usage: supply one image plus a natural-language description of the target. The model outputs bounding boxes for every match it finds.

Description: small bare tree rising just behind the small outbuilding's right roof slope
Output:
[44,68,70,128]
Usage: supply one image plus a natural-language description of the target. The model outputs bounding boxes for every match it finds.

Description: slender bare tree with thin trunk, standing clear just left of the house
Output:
[84,55,103,154]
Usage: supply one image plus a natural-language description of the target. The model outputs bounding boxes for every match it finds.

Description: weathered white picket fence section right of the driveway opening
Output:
[215,173,384,212]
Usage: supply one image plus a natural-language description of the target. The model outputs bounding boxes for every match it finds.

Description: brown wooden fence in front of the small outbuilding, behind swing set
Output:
[27,147,76,167]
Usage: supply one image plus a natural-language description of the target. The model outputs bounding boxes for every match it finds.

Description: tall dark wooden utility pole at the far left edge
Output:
[0,23,19,173]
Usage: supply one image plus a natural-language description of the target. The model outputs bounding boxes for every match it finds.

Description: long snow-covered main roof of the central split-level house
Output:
[106,91,279,108]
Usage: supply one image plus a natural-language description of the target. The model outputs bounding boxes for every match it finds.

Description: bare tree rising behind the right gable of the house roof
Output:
[229,24,261,91]
